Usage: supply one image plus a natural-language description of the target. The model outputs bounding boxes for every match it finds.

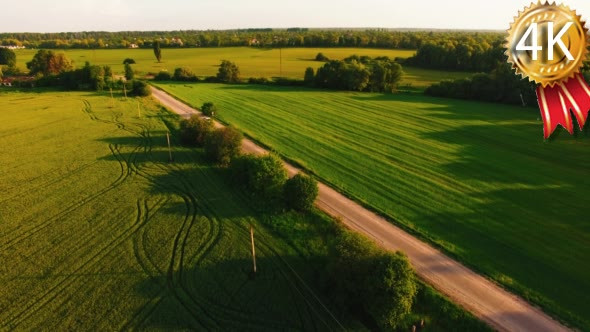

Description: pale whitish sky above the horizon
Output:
[0,0,590,32]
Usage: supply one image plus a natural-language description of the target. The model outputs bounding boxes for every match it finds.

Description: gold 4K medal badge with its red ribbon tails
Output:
[506,2,590,138]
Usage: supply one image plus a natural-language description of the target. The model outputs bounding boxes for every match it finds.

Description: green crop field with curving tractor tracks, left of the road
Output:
[0,89,485,331]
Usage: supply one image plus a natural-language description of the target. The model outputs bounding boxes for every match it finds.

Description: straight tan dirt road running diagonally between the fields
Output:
[151,87,569,332]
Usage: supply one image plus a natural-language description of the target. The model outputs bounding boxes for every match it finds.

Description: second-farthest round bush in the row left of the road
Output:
[205,127,243,166]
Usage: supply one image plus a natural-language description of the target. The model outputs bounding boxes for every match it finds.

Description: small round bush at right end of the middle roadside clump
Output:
[283,173,318,211]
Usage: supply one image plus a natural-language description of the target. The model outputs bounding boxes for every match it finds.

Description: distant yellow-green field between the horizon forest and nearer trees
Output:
[16,47,470,87]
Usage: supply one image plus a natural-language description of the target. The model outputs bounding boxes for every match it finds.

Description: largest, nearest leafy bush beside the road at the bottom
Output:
[328,231,417,330]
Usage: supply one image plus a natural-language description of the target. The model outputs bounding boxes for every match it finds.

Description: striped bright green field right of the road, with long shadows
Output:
[158,83,590,329]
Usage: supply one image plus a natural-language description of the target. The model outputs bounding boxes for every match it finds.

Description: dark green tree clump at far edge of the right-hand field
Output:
[304,55,403,92]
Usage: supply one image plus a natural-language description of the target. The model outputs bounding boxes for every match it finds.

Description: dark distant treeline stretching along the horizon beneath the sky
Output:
[0,28,502,49]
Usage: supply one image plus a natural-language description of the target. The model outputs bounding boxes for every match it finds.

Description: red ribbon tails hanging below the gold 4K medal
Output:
[537,74,590,139]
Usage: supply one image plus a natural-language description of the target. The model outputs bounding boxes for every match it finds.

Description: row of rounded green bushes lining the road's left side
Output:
[180,109,418,330]
